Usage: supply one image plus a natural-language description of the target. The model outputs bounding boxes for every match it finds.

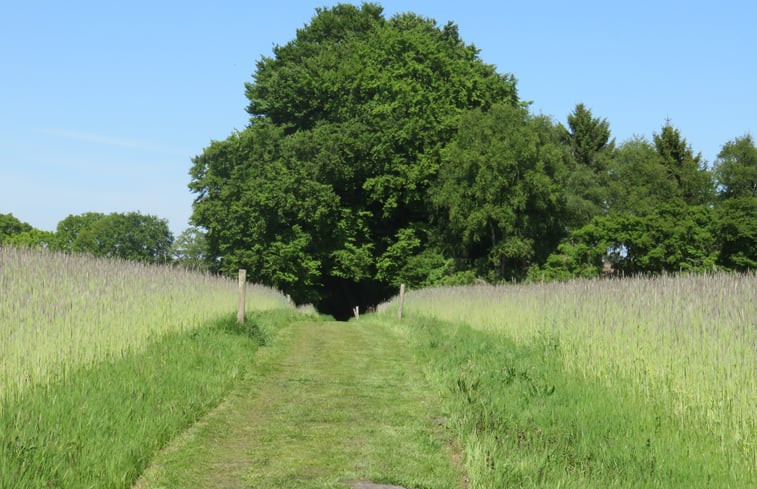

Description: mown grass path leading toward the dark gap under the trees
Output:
[136,320,461,489]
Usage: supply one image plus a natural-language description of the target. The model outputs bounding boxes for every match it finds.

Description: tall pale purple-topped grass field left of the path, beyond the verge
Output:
[0,247,288,400]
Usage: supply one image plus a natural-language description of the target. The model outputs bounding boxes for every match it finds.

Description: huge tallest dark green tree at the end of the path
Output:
[190,3,519,307]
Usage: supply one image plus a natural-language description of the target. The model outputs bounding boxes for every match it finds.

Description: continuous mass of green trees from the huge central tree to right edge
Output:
[185,4,755,309]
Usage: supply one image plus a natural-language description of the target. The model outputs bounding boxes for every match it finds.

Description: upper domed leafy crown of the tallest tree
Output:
[247,4,517,223]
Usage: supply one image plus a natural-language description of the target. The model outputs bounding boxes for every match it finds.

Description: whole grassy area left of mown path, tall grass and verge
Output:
[0,247,298,488]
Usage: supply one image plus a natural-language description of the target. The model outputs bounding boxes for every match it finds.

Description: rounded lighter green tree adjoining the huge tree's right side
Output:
[433,105,568,280]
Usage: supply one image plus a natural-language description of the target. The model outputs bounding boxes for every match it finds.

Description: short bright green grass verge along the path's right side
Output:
[396,319,757,489]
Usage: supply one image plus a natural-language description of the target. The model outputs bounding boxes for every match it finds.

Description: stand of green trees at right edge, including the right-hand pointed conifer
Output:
[529,131,757,279]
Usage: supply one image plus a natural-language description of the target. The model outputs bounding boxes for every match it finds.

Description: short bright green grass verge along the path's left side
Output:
[0,310,300,489]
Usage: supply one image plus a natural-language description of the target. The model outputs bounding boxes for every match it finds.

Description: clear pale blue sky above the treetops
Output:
[0,0,757,234]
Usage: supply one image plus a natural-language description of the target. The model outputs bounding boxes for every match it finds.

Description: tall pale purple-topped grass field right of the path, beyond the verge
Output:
[384,273,757,477]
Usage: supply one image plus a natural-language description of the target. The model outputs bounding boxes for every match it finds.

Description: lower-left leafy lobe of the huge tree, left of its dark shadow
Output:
[192,121,340,301]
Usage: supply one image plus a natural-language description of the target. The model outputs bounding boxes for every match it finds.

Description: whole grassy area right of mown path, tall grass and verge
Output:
[380,273,757,488]
